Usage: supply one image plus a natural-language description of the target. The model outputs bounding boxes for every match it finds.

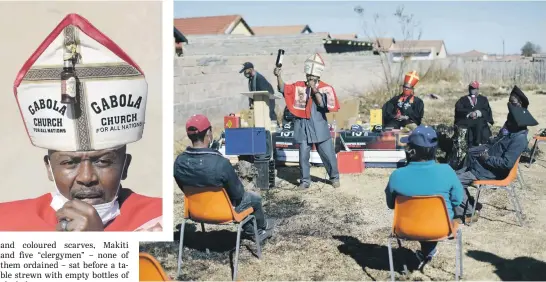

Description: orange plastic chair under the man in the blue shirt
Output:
[388,195,463,281]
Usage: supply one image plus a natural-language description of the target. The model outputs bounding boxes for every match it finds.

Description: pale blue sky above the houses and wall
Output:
[174,1,546,54]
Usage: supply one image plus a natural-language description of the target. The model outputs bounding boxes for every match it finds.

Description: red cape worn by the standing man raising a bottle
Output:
[284,81,339,119]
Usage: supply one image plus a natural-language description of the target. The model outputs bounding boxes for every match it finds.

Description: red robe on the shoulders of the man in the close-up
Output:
[0,188,163,232]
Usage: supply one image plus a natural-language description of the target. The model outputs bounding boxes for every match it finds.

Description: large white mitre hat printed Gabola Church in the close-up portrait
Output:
[13,14,148,151]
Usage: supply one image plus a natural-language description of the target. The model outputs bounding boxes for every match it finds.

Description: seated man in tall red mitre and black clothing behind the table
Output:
[383,71,425,129]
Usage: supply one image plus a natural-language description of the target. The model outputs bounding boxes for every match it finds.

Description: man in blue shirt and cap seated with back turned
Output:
[385,125,463,267]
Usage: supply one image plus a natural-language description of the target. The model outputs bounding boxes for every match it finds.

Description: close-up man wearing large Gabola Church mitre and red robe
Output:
[0,14,163,231]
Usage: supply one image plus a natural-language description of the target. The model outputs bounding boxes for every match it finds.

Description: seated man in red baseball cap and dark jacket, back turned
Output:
[174,115,273,241]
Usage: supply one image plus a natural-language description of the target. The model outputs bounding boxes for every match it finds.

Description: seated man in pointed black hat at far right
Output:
[455,86,538,222]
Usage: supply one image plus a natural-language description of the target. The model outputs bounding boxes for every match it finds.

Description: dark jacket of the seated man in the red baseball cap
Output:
[174,147,245,206]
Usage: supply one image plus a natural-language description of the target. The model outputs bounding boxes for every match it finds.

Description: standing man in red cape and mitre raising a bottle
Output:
[274,54,340,189]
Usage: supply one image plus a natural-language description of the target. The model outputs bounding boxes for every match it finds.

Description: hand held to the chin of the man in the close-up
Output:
[55,199,104,231]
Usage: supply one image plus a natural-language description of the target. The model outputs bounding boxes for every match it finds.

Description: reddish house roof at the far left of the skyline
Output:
[174,15,254,35]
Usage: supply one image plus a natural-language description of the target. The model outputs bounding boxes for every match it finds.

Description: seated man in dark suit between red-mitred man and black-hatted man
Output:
[455,81,494,148]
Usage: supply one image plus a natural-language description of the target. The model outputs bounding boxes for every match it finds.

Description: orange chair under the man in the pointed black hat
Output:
[468,157,523,226]
